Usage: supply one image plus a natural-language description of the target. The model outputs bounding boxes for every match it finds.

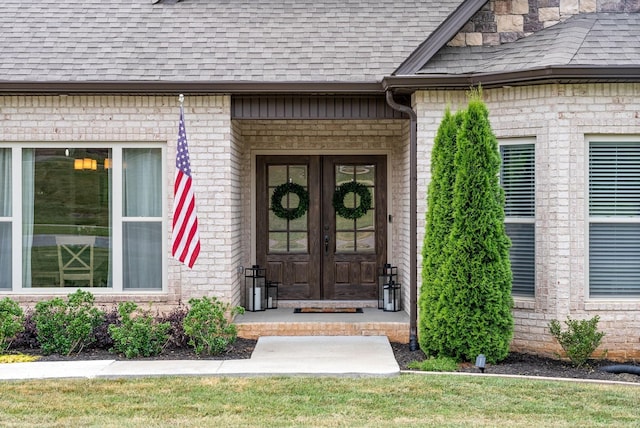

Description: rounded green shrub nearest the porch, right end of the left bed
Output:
[183,297,244,355]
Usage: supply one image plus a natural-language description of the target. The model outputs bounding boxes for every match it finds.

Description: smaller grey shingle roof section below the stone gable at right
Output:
[419,13,640,75]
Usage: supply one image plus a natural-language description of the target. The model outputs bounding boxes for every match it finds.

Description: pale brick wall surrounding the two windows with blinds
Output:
[415,83,640,360]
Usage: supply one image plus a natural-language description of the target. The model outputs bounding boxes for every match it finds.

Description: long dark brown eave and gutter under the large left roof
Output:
[0,81,384,95]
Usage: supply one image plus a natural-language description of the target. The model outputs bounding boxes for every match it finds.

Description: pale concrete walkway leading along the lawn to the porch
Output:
[0,336,400,380]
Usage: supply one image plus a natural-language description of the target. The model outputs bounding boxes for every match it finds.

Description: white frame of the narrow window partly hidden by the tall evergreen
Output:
[498,138,538,299]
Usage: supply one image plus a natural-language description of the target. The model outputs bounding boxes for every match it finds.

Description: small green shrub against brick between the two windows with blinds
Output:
[549,315,605,367]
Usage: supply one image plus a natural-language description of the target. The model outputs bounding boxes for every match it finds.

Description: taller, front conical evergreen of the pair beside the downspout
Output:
[420,90,513,363]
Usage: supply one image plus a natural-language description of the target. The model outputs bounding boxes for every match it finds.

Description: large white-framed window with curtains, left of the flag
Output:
[0,145,165,291]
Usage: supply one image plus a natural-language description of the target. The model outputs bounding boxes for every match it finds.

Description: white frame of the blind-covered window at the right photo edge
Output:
[585,135,640,301]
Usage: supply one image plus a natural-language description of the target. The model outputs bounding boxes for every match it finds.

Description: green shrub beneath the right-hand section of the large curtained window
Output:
[109,302,171,358]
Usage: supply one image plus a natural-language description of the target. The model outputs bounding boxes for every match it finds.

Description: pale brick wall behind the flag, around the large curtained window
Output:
[0,95,236,305]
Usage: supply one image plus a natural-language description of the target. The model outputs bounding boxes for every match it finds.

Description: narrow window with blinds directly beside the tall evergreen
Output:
[500,143,535,297]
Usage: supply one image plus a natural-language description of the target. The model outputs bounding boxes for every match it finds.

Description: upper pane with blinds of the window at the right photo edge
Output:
[589,142,640,217]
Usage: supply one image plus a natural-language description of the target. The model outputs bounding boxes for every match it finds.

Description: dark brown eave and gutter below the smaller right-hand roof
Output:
[382,65,640,92]
